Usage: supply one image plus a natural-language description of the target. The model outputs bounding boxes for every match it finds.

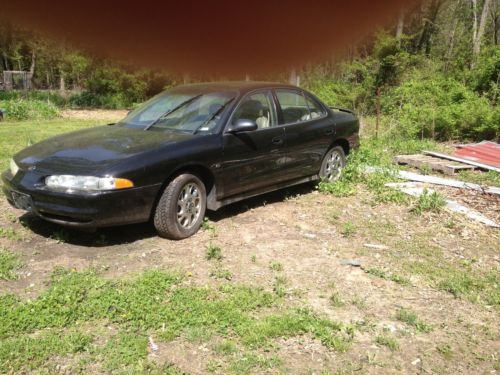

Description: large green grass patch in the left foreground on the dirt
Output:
[0,268,354,372]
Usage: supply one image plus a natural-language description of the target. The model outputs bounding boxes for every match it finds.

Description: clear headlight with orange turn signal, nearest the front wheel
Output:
[45,175,134,191]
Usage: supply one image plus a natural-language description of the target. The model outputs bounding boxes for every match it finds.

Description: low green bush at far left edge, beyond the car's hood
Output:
[0,99,59,120]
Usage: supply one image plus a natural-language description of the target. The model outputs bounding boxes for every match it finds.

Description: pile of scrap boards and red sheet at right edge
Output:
[387,142,500,228]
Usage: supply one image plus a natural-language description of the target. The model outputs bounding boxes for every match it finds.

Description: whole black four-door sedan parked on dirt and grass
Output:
[2,82,359,239]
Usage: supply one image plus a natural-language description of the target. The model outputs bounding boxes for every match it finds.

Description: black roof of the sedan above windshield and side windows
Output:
[169,81,298,95]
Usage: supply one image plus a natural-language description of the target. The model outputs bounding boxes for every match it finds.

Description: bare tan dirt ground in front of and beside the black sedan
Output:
[0,181,500,374]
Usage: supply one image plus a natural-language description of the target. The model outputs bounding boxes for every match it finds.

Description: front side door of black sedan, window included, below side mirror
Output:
[218,90,286,199]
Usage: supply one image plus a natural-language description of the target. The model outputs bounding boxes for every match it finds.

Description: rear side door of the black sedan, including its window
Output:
[274,89,335,179]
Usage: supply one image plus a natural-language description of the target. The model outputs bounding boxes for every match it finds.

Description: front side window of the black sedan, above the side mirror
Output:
[232,92,277,129]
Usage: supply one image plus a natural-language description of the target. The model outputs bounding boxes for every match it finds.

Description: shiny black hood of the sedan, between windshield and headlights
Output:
[14,125,193,175]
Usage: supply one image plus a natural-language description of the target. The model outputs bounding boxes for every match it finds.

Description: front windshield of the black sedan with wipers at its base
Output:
[119,91,236,133]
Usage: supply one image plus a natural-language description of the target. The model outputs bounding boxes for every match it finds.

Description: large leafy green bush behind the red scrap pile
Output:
[382,75,500,140]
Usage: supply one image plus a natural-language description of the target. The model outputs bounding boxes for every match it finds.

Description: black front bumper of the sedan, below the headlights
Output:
[2,171,161,228]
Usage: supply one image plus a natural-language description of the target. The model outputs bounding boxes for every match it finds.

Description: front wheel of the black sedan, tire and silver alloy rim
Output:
[153,173,207,240]
